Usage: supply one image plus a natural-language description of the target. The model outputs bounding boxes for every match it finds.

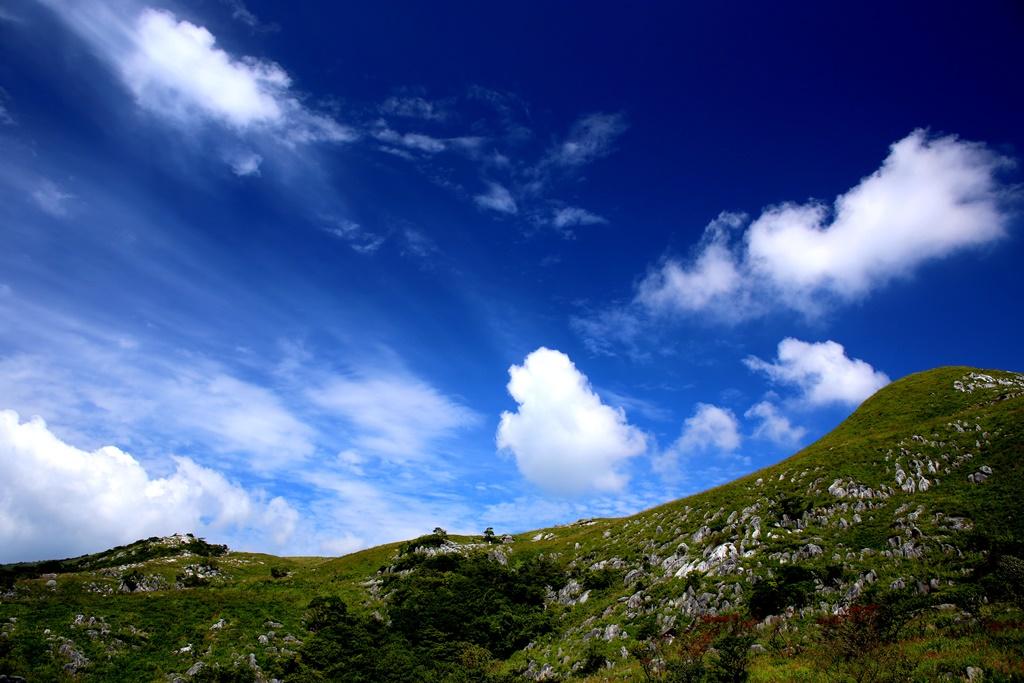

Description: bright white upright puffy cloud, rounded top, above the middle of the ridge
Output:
[497,347,647,495]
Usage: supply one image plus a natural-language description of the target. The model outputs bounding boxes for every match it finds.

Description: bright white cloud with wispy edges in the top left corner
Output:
[43,0,354,144]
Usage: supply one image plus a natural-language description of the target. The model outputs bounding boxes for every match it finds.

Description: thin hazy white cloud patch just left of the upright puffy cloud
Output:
[309,375,479,460]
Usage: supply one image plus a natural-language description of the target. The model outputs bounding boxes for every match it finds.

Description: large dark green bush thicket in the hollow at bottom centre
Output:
[281,553,565,683]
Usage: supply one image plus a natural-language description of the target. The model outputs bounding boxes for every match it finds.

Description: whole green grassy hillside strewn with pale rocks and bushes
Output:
[0,368,1024,681]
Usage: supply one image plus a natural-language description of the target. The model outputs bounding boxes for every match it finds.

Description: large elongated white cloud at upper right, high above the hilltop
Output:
[635,130,1010,318]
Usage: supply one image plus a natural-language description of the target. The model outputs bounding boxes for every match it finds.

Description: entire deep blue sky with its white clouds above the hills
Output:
[0,0,1024,561]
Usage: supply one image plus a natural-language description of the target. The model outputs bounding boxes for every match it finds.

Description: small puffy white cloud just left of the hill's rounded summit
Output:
[743,337,890,405]
